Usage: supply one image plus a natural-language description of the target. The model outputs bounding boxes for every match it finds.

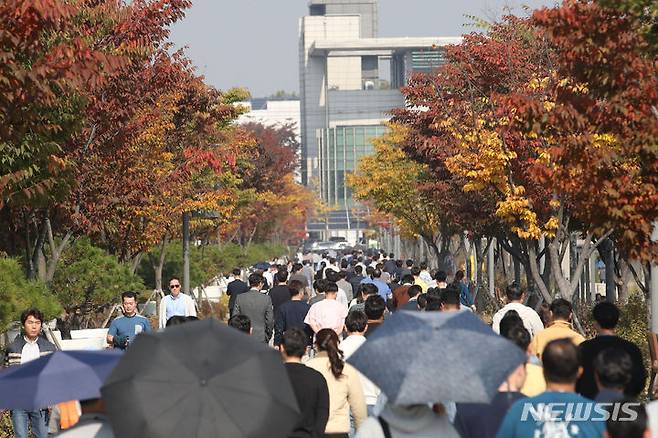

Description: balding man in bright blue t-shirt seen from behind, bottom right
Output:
[496,339,606,438]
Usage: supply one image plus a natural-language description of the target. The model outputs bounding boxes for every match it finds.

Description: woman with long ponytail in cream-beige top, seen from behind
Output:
[306,329,367,438]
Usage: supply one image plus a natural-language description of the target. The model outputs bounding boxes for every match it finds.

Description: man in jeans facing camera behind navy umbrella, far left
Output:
[4,308,57,438]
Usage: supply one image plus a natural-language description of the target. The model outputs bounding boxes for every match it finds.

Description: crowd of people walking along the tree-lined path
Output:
[0,252,658,438]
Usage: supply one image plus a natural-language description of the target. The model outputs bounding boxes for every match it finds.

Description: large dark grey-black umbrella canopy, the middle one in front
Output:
[101,319,299,438]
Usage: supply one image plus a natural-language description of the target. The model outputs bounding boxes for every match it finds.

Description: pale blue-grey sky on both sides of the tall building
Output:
[172,0,554,97]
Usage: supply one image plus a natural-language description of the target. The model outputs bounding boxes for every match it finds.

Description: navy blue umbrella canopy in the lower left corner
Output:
[0,350,123,411]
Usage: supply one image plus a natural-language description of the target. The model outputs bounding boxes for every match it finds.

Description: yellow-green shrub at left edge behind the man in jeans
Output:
[0,258,62,330]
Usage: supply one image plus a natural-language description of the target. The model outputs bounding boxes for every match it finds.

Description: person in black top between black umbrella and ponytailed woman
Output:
[281,328,329,438]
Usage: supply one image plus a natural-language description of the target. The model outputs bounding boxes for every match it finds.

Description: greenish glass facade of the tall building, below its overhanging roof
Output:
[317,125,387,207]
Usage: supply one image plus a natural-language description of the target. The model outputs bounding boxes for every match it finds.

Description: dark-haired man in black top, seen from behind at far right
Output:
[576,301,647,400]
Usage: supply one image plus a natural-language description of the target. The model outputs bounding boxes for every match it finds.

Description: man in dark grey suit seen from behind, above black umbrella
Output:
[233,274,274,344]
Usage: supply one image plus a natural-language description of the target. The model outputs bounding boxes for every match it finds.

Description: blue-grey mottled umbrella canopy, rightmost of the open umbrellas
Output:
[348,311,526,405]
